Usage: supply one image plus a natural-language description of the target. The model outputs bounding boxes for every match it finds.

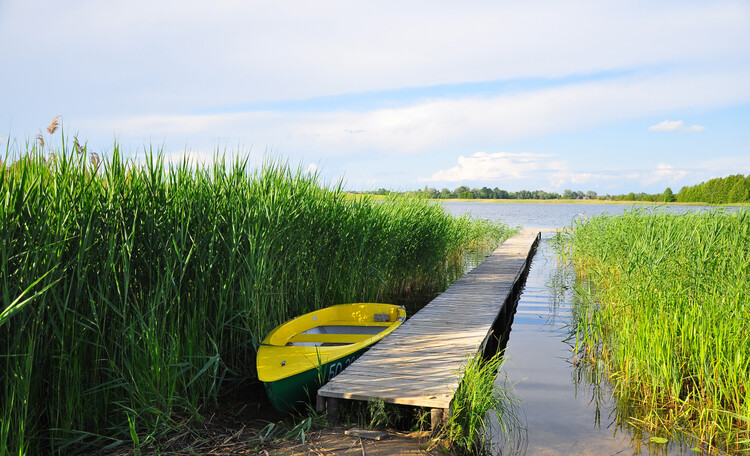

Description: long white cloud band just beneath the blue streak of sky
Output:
[83,66,750,157]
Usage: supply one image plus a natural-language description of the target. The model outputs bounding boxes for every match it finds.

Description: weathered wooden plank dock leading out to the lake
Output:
[317,230,540,425]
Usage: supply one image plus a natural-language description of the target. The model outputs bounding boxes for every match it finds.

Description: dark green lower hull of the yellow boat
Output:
[263,346,370,413]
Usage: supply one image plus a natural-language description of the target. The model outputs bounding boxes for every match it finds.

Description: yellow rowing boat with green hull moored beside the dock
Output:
[256,303,406,412]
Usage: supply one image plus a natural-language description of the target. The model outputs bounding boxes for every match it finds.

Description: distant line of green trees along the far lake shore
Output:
[363,174,750,204]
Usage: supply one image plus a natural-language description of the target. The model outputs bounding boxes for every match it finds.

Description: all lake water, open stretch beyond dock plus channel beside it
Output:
[444,202,728,456]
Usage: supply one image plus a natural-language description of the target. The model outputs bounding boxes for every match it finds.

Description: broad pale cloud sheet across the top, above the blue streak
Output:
[0,0,750,115]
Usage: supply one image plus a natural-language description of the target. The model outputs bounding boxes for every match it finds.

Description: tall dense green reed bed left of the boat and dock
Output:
[0,141,511,456]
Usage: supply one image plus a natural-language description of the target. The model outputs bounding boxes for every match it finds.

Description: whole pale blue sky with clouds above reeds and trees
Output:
[0,0,750,195]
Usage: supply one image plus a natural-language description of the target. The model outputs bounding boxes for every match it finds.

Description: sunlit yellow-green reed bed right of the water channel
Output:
[561,210,750,452]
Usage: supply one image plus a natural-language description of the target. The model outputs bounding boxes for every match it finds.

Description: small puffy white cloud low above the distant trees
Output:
[419,152,566,182]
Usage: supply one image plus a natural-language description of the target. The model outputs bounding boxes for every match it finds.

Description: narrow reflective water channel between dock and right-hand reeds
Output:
[493,234,712,456]
